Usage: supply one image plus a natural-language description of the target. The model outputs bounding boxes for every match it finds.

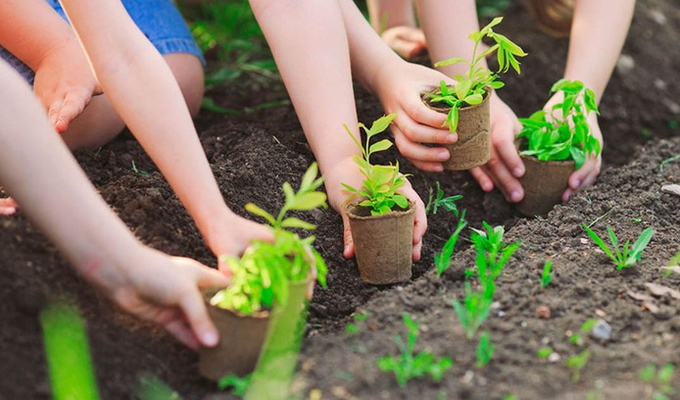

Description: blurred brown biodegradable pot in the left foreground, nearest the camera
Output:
[198,292,270,381]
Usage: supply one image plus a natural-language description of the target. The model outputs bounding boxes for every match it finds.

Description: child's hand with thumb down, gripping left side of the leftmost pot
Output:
[82,245,229,349]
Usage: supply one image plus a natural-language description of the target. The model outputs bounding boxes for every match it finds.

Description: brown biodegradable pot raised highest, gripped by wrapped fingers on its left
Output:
[422,86,491,171]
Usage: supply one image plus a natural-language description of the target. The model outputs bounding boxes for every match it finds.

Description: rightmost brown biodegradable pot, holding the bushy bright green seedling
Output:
[515,152,575,217]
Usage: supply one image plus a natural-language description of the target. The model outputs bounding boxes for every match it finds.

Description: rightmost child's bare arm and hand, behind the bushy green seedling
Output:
[546,0,635,201]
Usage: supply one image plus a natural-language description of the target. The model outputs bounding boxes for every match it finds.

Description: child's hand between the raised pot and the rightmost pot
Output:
[470,93,525,203]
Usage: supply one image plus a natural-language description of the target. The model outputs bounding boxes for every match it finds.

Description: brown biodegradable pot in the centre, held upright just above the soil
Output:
[347,201,416,285]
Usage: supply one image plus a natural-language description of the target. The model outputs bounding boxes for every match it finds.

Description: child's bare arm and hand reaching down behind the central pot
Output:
[250,0,428,260]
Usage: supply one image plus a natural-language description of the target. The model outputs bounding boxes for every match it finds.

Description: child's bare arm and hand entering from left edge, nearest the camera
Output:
[0,61,228,348]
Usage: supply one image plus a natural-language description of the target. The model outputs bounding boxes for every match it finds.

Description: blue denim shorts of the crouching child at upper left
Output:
[0,0,205,84]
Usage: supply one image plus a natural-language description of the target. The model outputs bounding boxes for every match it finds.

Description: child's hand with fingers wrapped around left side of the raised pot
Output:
[374,62,458,172]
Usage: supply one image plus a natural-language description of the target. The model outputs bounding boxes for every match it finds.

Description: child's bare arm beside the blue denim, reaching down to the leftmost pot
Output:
[55,0,271,268]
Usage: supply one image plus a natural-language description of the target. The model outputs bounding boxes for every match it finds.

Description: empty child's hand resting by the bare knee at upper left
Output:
[33,38,101,133]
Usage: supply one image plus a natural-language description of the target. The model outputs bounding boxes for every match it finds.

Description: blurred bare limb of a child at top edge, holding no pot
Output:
[367,0,427,58]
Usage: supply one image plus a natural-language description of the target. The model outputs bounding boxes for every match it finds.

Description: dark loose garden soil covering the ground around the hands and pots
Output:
[0,0,680,399]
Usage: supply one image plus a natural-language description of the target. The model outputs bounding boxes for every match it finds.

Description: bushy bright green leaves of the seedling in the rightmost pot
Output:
[517,79,601,169]
